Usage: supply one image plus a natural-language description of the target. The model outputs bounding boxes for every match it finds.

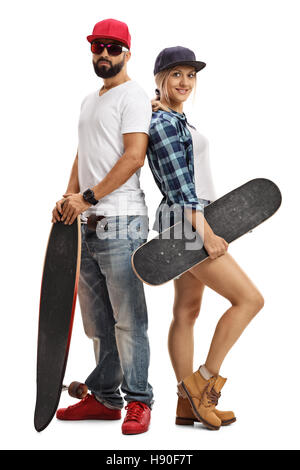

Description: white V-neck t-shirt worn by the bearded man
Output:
[78,80,152,222]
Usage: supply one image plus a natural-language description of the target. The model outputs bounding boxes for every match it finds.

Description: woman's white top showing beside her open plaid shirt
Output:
[187,125,217,202]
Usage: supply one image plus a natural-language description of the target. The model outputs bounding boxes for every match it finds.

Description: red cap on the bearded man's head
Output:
[87,18,131,49]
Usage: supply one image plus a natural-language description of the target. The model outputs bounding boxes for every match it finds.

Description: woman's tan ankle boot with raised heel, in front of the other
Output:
[178,370,230,430]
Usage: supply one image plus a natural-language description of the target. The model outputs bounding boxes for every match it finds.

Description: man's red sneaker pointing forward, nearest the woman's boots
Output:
[122,401,151,434]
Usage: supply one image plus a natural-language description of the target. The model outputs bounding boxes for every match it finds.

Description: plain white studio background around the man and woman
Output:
[0,0,300,450]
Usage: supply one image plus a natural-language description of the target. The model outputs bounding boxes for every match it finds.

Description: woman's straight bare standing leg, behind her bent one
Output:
[168,272,204,382]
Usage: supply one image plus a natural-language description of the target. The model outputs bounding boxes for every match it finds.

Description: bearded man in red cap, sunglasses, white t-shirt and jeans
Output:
[52,19,153,434]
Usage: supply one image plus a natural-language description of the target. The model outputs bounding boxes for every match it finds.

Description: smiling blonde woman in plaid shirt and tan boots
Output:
[147,47,264,430]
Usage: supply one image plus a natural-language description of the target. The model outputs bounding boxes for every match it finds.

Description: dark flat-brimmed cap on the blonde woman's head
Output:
[154,46,206,75]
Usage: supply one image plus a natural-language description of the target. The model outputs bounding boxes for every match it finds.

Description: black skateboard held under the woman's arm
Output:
[131,178,282,286]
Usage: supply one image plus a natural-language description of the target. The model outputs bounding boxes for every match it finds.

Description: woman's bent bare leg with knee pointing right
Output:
[189,252,264,375]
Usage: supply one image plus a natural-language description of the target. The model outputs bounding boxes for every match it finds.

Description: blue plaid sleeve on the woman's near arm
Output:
[150,120,203,212]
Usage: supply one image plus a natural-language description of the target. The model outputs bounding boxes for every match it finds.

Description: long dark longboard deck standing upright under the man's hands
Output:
[34,217,81,431]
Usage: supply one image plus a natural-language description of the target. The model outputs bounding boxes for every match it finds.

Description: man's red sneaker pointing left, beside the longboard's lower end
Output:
[56,394,121,421]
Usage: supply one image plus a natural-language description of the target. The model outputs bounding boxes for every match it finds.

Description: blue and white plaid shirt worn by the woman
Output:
[147,110,203,226]
